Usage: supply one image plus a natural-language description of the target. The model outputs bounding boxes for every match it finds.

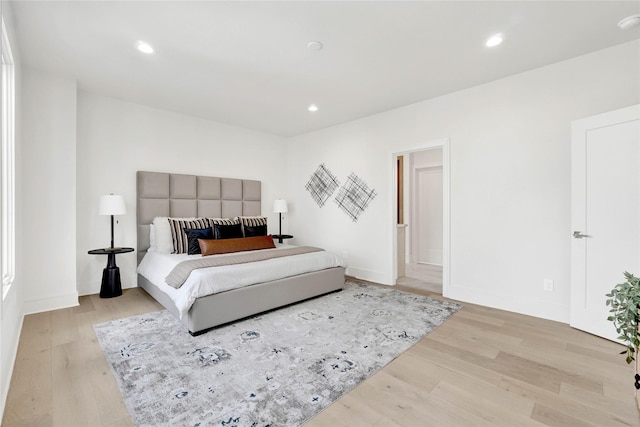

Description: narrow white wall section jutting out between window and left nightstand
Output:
[20,67,78,313]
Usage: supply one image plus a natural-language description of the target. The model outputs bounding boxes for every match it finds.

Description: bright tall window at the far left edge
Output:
[0,15,15,300]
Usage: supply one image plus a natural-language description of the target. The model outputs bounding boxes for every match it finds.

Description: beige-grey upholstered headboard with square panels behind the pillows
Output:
[136,171,262,262]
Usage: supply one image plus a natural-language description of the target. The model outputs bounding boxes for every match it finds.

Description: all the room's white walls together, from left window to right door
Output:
[8,33,640,320]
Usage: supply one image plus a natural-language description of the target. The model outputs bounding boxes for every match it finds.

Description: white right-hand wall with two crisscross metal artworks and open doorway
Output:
[288,41,640,322]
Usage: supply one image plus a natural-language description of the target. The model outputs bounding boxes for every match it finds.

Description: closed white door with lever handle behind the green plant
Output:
[569,105,640,341]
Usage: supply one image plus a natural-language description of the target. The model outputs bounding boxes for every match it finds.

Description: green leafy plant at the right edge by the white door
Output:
[606,271,640,409]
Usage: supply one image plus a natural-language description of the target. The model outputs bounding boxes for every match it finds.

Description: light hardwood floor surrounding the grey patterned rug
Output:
[3,287,640,427]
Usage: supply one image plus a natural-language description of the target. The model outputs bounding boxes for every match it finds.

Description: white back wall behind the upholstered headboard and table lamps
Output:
[76,91,286,295]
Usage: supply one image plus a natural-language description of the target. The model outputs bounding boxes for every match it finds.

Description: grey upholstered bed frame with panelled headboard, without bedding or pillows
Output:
[136,171,345,335]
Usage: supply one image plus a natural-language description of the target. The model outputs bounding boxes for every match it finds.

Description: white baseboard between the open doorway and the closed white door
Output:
[444,284,569,324]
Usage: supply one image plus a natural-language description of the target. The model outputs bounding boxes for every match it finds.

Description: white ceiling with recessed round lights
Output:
[11,1,640,136]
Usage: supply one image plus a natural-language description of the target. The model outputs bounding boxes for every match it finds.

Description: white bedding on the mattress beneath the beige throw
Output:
[138,245,346,318]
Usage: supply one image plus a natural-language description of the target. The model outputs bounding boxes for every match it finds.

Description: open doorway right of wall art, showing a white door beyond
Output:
[393,140,449,295]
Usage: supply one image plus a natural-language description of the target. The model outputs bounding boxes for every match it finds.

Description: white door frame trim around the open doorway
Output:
[389,138,451,297]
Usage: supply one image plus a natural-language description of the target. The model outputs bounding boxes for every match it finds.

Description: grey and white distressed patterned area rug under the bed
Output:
[94,281,461,426]
